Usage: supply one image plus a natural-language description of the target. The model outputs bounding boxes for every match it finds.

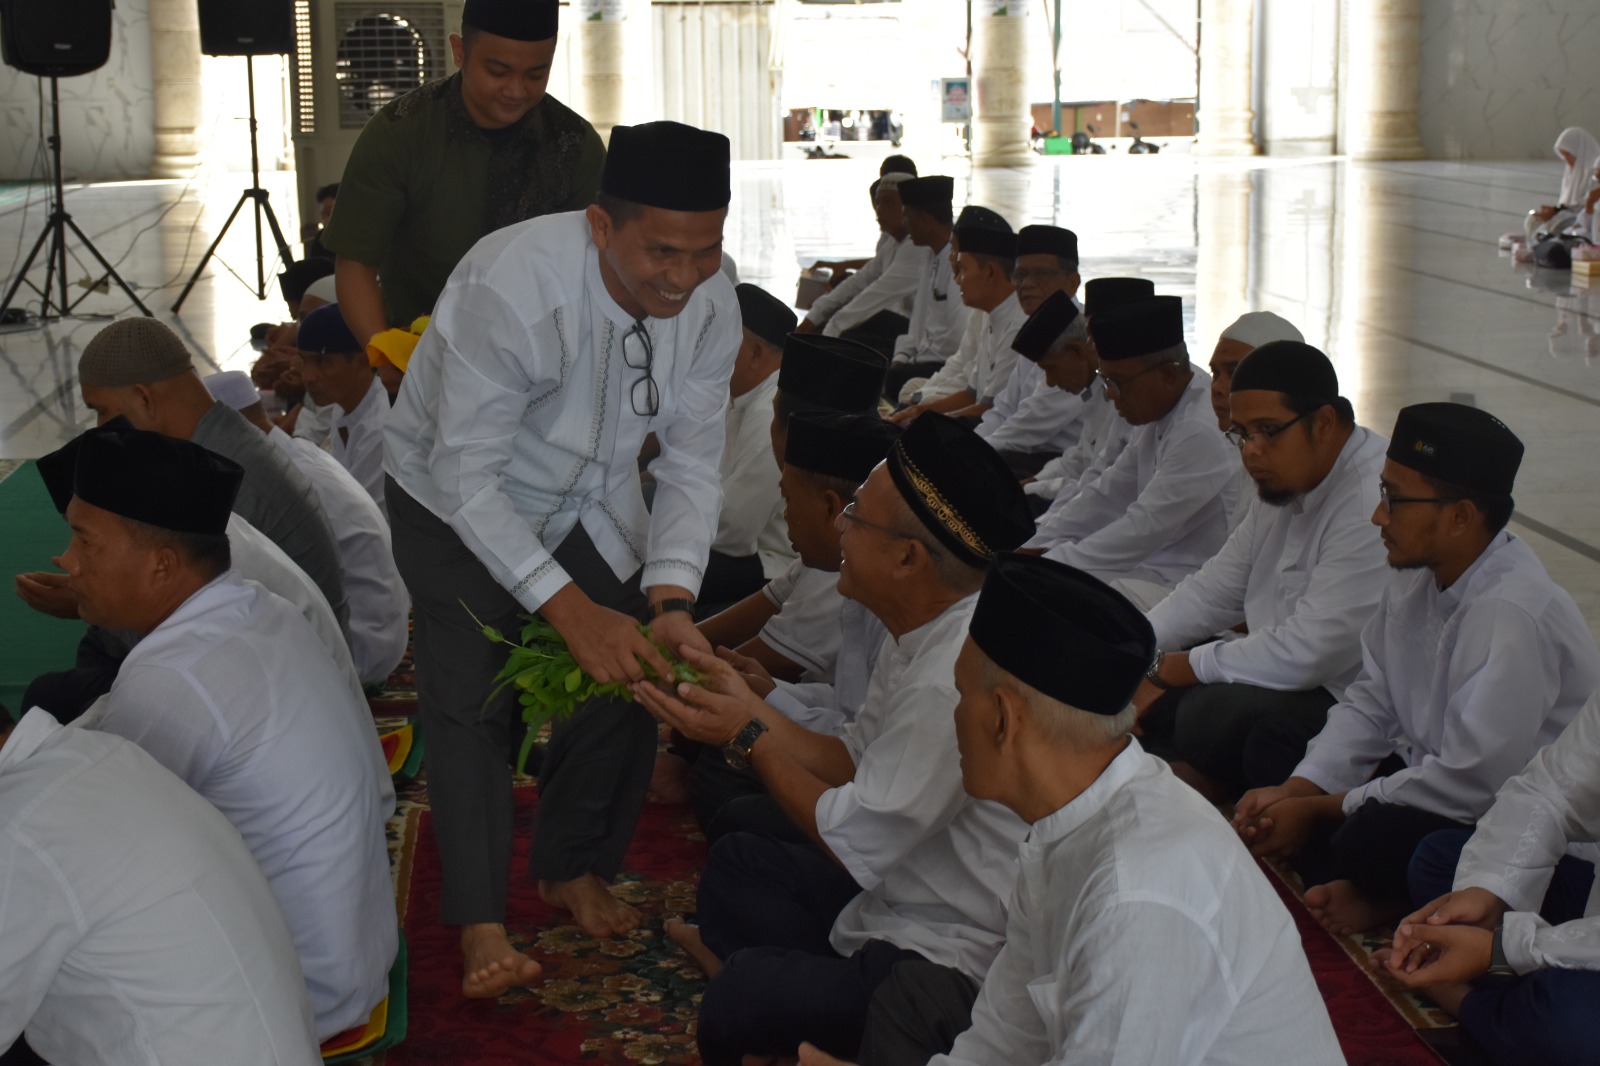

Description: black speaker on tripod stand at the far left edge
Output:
[0,0,150,319]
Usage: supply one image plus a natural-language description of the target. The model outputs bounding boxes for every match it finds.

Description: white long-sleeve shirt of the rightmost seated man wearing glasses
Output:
[1294,531,1600,823]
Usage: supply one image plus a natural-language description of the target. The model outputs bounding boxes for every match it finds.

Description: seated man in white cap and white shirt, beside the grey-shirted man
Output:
[205,370,411,685]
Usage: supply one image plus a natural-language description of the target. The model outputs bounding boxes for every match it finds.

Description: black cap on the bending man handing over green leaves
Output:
[600,120,733,211]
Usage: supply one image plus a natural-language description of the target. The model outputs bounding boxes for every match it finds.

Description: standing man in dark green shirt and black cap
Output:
[322,0,605,352]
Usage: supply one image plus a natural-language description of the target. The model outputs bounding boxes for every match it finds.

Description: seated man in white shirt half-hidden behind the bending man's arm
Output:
[699,283,798,616]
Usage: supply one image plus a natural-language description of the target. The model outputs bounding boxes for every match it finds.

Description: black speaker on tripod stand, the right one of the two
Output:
[173,0,294,314]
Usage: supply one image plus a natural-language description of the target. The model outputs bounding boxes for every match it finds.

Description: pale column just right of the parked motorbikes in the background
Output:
[1195,0,1258,155]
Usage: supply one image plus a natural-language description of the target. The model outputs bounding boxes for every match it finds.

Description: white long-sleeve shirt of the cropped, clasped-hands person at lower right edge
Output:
[1454,696,1600,973]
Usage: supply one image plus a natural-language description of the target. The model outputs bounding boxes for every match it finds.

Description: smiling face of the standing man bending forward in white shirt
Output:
[589,205,728,319]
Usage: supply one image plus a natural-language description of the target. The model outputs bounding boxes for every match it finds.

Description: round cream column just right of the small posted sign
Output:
[971,0,1034,166]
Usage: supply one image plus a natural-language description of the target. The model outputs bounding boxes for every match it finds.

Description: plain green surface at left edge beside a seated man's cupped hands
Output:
[0,463,83,715]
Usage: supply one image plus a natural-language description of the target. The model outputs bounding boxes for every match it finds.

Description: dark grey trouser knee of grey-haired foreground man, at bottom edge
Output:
[858,959,979,1066]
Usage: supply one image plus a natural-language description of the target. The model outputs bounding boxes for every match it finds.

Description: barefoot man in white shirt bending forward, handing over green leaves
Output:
[384,122,739,999]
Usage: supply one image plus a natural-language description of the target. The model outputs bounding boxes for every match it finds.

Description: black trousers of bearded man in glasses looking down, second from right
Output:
[1141,683,1334,795]
